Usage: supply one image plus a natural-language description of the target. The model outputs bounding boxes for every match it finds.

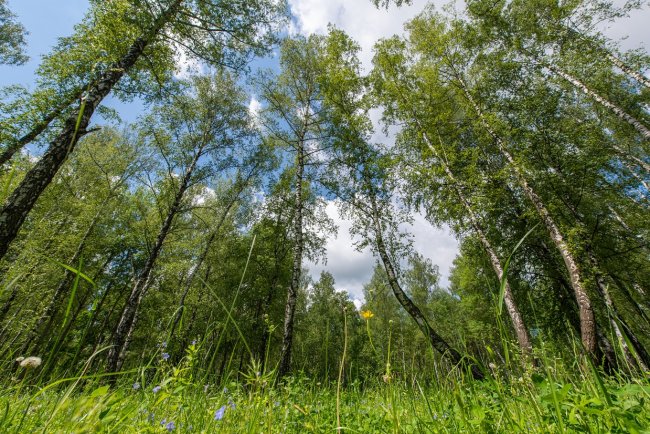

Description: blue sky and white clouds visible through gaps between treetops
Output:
[0,0,650,306]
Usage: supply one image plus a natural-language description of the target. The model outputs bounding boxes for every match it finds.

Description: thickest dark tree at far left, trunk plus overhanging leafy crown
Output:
[0,0,283,257]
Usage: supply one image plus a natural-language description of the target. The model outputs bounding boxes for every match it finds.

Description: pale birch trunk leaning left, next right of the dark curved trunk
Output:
[416,125,533,356]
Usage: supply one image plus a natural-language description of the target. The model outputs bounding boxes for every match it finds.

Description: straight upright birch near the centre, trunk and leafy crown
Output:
[257,36,340,376]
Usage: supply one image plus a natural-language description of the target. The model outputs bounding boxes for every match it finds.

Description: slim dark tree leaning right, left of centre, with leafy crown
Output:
[107,72,250,372]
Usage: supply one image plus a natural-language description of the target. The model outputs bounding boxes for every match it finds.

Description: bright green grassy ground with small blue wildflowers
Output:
[0,367,650,433]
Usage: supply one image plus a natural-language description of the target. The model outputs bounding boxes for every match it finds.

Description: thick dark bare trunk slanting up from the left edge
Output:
[0,0,183,259]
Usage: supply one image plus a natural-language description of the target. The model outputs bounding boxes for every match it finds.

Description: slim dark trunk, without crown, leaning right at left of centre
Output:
[107,143,202,378]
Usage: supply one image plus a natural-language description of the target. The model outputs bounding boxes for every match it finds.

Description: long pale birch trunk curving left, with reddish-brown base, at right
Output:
[458,77,596,356]
